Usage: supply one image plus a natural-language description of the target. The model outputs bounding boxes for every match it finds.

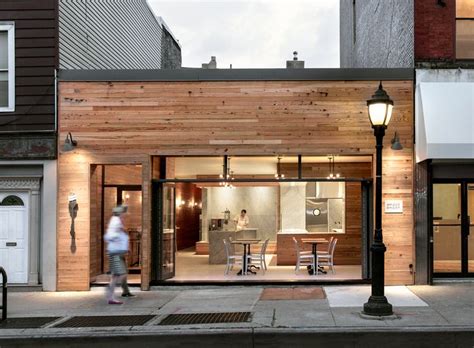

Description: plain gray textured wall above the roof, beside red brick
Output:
[340,0,414,68]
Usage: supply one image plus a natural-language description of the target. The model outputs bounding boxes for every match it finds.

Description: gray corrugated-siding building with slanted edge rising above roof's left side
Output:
[59,0,181,70]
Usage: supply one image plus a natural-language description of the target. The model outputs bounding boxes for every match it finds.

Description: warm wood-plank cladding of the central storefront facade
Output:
[57,69,415,290]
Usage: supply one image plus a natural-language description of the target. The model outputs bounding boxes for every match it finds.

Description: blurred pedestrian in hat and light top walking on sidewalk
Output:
[104,205,135,304]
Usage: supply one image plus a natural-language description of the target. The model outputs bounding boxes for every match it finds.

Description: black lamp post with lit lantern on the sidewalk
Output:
[362,82,393,316]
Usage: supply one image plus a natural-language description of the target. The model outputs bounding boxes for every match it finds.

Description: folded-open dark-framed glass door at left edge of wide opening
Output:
[153,183,176,281]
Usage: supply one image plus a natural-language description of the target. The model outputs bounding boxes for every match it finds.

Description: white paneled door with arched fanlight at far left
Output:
[0,192,28,283]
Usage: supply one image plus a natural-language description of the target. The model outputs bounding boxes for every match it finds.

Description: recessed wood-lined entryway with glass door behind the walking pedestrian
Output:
[90,164,142,284]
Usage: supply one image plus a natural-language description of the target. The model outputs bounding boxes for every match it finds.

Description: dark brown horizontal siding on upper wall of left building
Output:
[0,0,58,133]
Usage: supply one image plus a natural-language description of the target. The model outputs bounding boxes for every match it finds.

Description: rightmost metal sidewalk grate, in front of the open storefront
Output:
[158,312,251,325]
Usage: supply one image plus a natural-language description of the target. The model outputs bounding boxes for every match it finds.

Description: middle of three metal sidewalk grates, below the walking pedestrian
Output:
[54,315,155,328]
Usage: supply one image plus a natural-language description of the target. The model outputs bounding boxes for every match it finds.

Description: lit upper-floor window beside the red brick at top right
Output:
[456,0,474,59]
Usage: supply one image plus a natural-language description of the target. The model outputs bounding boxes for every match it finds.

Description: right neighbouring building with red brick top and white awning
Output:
[414,0,474,284]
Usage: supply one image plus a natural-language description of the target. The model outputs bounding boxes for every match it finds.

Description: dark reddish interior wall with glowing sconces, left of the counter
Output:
[176,183,202,250]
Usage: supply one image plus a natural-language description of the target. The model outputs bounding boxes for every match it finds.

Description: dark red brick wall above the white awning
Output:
[415,0,456,61]
